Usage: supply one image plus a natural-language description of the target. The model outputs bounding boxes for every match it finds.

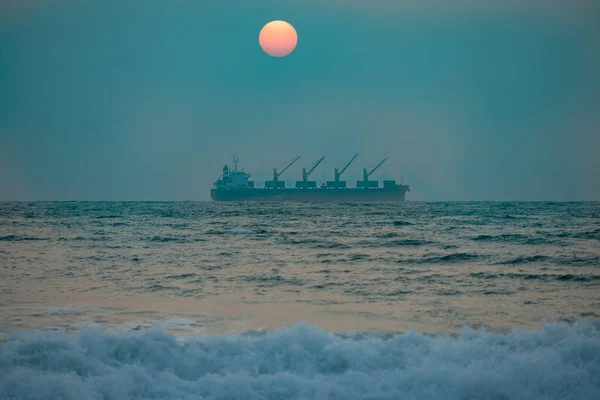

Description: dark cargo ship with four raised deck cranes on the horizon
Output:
[210,153,410,202]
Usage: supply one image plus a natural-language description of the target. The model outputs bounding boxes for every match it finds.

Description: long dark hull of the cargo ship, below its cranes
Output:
[210,186,408,202]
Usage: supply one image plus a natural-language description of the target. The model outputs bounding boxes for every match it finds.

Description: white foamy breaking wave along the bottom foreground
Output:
[0,322,600,400]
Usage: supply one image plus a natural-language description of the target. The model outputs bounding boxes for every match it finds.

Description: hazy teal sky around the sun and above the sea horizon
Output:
[0,0,600,200]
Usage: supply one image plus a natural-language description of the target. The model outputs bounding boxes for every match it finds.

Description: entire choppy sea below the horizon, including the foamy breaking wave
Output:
[0,202,600,400]
